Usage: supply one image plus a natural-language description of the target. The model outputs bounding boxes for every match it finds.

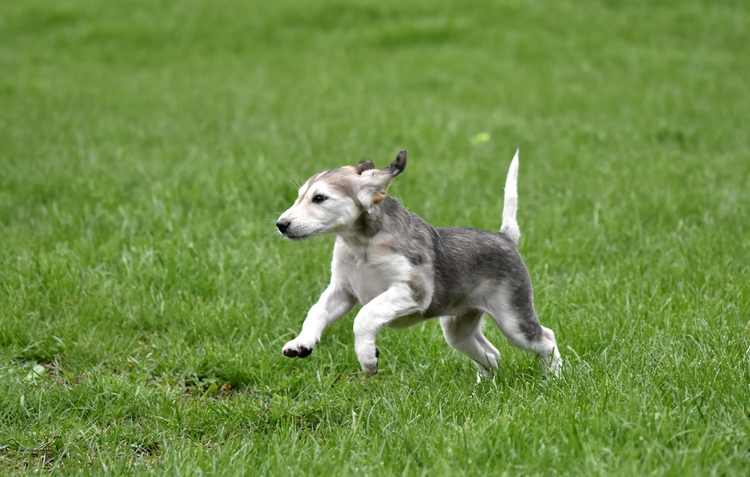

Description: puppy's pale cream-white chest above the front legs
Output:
[333,242,412,305]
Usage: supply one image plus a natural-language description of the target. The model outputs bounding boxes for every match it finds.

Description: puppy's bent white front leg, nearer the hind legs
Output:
[354,283,424,376]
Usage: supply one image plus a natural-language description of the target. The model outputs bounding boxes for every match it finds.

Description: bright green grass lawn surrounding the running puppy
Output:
[0,0,750,475]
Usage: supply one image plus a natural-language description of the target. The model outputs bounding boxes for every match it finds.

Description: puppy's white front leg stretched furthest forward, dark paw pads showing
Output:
[282,283,356,358]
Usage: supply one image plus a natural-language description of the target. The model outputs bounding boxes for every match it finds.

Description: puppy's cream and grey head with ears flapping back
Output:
[276,151,406,240]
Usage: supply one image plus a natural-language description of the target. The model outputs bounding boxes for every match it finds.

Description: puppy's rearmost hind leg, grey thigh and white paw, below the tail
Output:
[485,286,562,375]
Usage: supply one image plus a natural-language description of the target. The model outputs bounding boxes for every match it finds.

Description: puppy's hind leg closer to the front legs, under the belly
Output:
[440,310,500,377]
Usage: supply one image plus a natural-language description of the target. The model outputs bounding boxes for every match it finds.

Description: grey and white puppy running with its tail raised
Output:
[276,151,562,376]
